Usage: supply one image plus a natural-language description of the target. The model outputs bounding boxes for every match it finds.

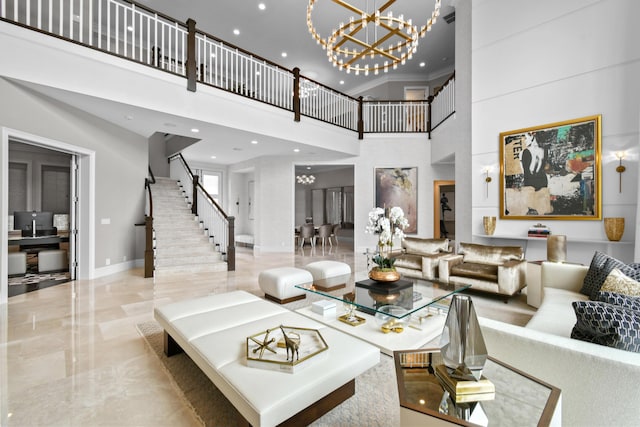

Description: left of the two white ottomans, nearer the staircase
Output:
[258,267,313,304]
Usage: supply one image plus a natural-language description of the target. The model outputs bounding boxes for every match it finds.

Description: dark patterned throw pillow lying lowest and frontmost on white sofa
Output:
[571,301,640,353]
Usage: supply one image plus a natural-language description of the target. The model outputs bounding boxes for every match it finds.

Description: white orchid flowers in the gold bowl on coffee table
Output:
[365,206,409,268]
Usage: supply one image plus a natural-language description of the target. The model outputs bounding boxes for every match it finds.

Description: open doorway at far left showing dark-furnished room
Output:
[7,140,76,297]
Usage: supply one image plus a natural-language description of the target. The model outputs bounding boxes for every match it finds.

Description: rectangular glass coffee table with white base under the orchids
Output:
[296,276,471,356]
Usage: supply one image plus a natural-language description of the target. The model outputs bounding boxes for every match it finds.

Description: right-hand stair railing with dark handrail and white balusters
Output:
[169,153,236,271]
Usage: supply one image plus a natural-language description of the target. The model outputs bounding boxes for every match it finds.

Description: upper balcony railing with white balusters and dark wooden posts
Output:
[0,0,455,139]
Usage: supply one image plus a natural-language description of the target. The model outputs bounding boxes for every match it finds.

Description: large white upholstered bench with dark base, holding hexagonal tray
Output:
[155,291,380,426]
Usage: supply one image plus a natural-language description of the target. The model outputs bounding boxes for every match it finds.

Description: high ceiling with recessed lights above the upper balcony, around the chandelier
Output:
[140,0,455,94]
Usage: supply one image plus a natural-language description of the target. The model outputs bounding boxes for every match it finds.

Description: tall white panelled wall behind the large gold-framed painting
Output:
[470,0,640,263]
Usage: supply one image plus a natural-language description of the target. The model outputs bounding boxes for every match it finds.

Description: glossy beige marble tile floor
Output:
[0,245,533,426]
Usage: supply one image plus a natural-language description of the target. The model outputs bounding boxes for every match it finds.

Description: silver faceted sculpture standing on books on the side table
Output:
[440,295,487,381]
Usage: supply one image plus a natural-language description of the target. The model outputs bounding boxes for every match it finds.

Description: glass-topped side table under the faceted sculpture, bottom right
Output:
[393,349,561,427]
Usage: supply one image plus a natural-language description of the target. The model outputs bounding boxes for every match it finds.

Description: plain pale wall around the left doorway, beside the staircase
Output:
[0,78,148,271]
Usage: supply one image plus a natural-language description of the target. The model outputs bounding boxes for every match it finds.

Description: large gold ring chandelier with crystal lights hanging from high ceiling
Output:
[307,0,441,76]
